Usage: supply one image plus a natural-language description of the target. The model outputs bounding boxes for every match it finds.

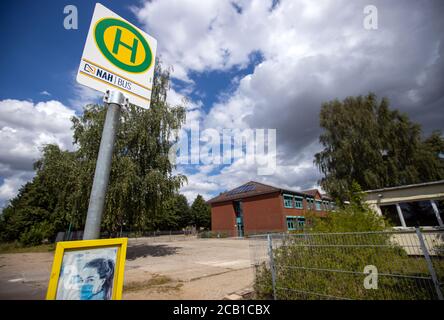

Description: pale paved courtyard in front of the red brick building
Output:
[0,237,253,299]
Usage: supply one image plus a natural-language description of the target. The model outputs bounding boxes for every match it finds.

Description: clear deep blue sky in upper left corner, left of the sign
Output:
[0,1,99,103]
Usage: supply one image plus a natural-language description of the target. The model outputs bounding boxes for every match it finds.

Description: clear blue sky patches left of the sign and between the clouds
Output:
[0,0,261,112]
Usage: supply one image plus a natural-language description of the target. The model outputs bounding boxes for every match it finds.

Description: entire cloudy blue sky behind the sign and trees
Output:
[0,0,444,206]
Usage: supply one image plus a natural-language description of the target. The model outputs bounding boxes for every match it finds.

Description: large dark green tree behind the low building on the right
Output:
[314,93,444,200]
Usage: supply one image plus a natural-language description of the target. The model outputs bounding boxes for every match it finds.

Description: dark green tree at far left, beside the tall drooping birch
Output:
[0,145,77,244]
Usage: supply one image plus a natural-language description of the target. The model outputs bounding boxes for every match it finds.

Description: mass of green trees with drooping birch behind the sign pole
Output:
[0,63,186,242]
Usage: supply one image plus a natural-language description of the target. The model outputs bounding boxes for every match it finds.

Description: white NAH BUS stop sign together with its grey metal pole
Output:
[77,3,157,240]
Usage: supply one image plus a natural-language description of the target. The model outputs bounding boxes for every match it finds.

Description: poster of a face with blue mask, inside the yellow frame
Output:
[56,248,118,300]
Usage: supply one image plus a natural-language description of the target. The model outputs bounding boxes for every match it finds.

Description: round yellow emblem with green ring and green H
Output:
[94,18,153,73]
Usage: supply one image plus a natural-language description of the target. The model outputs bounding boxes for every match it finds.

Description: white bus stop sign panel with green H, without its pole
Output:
[77,3,157,108]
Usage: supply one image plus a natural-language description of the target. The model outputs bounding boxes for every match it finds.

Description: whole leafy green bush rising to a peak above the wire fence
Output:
[254,188,442,300]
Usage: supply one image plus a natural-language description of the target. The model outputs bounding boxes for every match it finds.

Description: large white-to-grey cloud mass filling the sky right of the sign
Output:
[134,0,444,200]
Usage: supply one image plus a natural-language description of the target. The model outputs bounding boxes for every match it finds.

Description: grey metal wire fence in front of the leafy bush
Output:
[249,229,444,300]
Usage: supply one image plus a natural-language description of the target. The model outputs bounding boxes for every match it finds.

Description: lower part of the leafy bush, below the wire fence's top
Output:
[255,234,434,300]
